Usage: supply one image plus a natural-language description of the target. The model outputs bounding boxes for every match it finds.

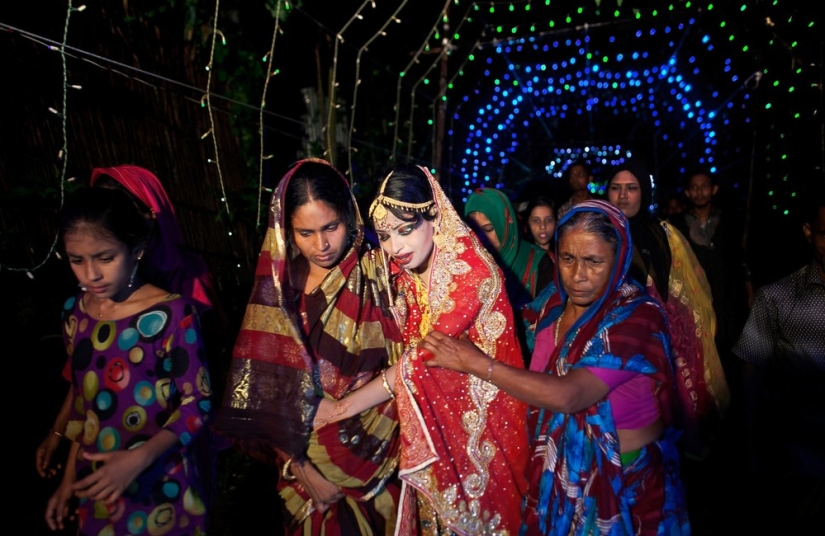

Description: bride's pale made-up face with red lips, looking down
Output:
[373,211,435,273]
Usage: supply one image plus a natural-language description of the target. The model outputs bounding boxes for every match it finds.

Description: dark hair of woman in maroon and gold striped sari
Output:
[284,162,358,240]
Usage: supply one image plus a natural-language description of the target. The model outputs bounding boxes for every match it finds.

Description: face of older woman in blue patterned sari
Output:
[557,229,616,308]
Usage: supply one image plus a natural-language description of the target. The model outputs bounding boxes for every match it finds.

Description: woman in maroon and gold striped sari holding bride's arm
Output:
[217,159,401,535]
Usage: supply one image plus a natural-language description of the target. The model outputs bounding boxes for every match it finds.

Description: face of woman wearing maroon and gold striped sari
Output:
[291,200,347,270]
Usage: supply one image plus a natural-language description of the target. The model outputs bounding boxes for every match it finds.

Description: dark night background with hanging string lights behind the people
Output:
[0,0,825,535]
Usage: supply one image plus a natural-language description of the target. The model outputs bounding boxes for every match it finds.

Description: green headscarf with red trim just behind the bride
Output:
[464,188,545,306]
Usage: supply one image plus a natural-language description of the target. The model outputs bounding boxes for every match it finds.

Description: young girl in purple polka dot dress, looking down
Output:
[46,188,211,536]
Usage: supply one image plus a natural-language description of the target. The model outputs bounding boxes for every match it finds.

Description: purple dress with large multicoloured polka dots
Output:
[63,295,212,536]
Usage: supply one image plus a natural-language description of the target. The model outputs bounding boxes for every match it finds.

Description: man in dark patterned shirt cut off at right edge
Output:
[733,195,825,534]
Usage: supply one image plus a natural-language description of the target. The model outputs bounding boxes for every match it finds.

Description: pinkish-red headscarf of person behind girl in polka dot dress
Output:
[90,164,213,307]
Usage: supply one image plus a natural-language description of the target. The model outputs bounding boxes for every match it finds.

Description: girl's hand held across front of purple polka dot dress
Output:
[71,447,149,504]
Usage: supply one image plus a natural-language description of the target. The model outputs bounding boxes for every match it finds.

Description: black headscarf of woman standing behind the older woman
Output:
[607,159,671,300]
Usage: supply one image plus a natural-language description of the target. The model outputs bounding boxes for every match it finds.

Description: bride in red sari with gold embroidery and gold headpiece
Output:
[315,167,528,535]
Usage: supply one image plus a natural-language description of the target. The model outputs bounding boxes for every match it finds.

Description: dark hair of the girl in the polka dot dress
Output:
[60,187,152,250]
